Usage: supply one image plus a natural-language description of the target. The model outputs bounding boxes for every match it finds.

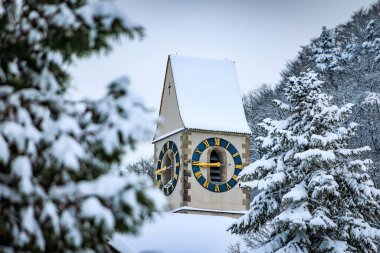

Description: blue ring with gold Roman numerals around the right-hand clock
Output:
[192,137,243,193]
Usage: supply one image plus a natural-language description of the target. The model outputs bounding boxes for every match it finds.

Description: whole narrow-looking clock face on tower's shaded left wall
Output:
[155,141,180,196]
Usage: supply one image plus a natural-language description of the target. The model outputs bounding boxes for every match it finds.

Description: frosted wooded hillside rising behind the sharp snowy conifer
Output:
[244,1,380,188]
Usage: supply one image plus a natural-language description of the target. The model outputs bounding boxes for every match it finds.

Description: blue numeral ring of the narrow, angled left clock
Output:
[156,141,181,196]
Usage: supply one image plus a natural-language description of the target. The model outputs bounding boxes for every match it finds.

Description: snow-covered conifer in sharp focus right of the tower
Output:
[230,72,380,253]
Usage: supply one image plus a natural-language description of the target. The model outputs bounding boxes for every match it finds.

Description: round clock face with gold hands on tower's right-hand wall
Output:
[192,137,242,192]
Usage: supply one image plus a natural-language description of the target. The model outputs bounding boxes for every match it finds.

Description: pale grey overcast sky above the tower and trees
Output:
[69,0,375,162]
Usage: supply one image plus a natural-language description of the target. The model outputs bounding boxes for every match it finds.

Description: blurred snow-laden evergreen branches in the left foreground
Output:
[0,0,163,253]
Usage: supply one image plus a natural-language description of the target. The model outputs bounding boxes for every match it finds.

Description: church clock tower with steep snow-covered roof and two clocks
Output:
[153,55,250,217]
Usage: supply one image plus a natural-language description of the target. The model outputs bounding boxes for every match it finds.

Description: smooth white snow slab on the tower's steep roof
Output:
[169,55,251,133]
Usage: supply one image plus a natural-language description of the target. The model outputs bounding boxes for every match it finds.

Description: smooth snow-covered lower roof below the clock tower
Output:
[110,213,241,253]
